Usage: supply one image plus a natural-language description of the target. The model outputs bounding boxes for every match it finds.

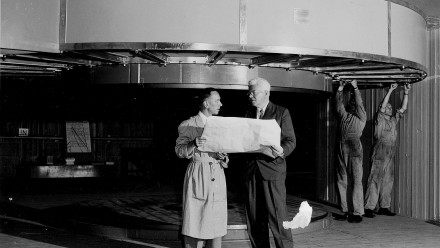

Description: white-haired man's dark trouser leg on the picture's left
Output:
[245,170,270,248]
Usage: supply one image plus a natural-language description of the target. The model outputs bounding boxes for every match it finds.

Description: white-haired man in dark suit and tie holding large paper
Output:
[244,78,296,248]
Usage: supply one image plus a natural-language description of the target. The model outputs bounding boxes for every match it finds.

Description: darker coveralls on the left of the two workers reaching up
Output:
[336,90,367,216]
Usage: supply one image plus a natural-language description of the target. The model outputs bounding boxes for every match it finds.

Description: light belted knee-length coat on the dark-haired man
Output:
[175,112,228,239]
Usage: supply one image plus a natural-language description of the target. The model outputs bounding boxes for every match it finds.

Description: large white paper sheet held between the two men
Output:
[198,116,282,157]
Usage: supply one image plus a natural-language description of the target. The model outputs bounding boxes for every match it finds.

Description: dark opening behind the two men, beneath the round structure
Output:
[0,78,328,201]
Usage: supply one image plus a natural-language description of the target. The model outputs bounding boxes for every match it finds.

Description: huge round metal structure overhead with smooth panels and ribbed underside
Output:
[1,0,426,91]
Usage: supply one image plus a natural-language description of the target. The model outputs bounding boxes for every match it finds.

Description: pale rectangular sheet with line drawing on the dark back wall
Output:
[66,121,92,153]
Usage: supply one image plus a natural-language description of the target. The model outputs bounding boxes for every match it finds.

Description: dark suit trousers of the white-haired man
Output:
[246,169,293,248]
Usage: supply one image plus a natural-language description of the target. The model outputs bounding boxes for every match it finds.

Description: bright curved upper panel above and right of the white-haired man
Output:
[247,0,388,55]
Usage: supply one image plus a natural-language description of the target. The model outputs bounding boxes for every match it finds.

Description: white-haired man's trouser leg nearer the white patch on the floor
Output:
[263,180,293,248]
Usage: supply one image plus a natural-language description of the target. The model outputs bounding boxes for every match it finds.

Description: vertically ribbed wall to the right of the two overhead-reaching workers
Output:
[393,24,434,220]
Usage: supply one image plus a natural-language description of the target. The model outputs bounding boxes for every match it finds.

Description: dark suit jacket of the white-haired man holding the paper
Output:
[244,102,296,180]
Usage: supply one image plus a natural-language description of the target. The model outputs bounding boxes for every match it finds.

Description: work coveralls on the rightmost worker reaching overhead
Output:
[365,109,403,210]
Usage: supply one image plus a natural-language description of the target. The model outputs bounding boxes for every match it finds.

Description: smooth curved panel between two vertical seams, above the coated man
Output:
[66,0,239,44]
